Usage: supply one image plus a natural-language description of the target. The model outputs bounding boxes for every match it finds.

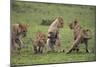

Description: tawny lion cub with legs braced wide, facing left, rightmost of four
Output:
[68,20,91,53]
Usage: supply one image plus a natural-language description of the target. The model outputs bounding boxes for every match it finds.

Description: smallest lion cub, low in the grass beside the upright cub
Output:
[33,32,47,53]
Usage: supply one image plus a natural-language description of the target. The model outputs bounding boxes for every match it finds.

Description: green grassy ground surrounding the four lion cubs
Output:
[11,1,96,65]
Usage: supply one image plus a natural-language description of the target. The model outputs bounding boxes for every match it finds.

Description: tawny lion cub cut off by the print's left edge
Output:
[11,24,28,50]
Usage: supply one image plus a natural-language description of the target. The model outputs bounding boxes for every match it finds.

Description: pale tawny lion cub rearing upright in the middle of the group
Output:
[47,17,64,51]
